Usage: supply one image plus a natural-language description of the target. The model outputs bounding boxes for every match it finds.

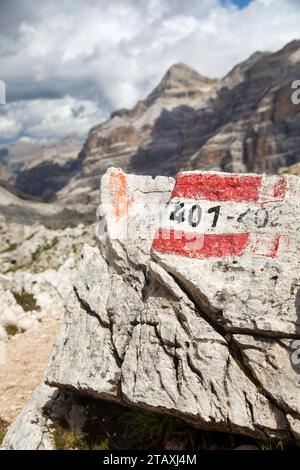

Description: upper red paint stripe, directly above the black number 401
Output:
[172,173,262,202]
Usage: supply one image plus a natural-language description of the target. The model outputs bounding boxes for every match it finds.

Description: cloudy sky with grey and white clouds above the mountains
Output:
[0,0,300,143]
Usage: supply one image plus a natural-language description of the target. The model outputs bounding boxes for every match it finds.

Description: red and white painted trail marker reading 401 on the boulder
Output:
[153,173,291,258]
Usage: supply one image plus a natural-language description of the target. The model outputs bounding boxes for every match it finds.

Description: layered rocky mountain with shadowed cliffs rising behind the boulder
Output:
[59,41,300,206]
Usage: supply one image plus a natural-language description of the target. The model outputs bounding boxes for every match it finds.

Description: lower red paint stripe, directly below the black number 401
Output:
[152,229,249,258]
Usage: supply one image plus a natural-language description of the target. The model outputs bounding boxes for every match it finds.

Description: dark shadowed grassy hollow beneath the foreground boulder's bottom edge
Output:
[54,397,283,451]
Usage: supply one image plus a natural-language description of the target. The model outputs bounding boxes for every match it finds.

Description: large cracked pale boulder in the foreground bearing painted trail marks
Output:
[41,169,300,442]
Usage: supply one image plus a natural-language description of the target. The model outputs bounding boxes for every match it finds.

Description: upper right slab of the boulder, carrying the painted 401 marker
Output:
[152,171,300,333]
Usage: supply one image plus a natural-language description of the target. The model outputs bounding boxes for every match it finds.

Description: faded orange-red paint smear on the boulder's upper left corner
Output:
[109,169,130,220]
